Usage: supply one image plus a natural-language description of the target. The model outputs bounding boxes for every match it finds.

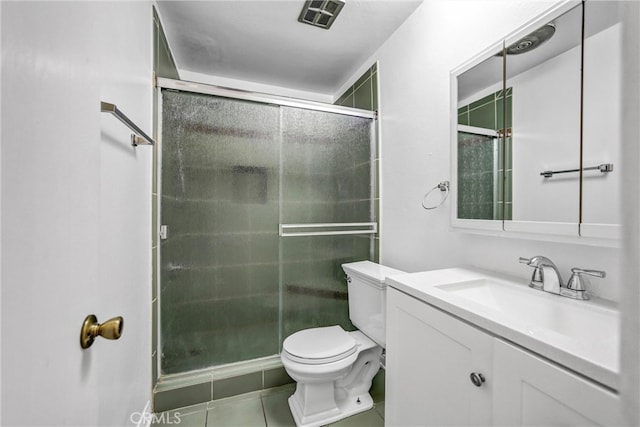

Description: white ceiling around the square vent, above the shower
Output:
[158,0,422,96]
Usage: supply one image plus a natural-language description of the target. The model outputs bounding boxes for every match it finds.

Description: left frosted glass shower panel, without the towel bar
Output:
[160,90,280,374]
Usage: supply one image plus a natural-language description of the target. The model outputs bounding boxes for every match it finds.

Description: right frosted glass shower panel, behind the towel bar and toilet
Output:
[280,107,376,339]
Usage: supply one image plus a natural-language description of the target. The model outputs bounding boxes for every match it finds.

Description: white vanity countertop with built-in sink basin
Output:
[386,268,620,389]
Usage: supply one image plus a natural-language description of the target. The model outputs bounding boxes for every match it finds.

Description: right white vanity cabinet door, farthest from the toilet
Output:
[493,339,622,426]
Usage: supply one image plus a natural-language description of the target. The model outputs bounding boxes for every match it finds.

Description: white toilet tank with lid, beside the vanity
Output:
[342,261,404,348]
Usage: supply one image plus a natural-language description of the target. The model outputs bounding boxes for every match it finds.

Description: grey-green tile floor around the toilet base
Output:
[152,384,384,427]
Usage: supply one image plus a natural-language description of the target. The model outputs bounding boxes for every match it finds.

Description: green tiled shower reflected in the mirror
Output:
[458,88,513,220]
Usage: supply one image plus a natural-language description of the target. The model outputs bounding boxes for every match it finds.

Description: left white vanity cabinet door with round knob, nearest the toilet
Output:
[385,287,493,426]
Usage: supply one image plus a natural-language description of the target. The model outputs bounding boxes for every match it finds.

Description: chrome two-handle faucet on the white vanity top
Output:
[520,255,607,300]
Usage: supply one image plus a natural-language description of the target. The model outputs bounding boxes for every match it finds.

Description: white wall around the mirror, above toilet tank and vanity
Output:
[354,0,620,300]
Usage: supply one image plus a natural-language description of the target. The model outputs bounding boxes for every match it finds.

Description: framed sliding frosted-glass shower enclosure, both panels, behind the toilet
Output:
[157,79,378,375]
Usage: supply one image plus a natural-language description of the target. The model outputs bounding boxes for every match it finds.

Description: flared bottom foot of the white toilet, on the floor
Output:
[289,393,373,427]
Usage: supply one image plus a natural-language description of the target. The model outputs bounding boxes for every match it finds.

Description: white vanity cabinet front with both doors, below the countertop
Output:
[385,287,622,426]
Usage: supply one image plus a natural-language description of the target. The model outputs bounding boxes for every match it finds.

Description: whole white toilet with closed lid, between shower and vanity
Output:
[280,261,403,427]
